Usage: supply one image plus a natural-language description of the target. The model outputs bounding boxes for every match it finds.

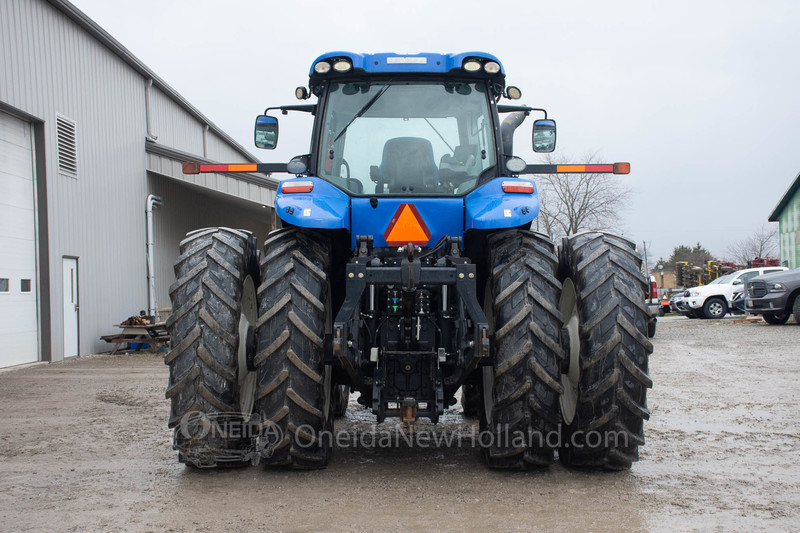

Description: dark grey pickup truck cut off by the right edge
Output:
[745,268,800,324]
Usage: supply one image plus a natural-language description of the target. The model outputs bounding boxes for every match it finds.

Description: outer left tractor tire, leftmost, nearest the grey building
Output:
[165,228,259,468]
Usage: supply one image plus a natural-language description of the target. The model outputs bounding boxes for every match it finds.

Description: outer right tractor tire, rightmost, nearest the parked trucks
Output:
[559,233,653,470]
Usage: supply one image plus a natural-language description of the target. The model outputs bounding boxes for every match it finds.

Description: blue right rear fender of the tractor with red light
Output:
[464,178,539,231]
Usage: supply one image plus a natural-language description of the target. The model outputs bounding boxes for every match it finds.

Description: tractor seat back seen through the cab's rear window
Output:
[376,137,439,193]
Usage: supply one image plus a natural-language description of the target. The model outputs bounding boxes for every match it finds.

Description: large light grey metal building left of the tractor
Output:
[0,0,277,366]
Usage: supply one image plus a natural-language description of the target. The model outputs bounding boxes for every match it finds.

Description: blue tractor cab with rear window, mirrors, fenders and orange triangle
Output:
[255,52,555,247]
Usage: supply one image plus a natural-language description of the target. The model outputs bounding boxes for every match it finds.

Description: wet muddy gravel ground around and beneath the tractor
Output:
[0,317,800,531]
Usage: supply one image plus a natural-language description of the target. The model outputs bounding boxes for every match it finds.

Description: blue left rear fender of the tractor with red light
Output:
[275,176,350,231]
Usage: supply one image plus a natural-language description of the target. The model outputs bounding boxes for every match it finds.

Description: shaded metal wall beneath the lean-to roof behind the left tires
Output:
[148,173,272,307]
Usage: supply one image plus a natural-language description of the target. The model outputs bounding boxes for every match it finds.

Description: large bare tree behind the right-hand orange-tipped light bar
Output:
[533,154,630,238]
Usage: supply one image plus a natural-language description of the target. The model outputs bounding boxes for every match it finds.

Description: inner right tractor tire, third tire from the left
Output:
[480,230,563,469]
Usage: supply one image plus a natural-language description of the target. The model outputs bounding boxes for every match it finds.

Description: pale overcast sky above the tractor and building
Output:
[72,0,800,260]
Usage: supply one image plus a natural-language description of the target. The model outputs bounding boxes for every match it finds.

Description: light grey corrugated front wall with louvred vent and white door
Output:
[0,0,147,360]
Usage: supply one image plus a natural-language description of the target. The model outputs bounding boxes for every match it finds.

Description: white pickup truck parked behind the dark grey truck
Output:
[676,267,789,318]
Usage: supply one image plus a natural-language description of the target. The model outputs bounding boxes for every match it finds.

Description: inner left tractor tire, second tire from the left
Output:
[254,229,334,469]
